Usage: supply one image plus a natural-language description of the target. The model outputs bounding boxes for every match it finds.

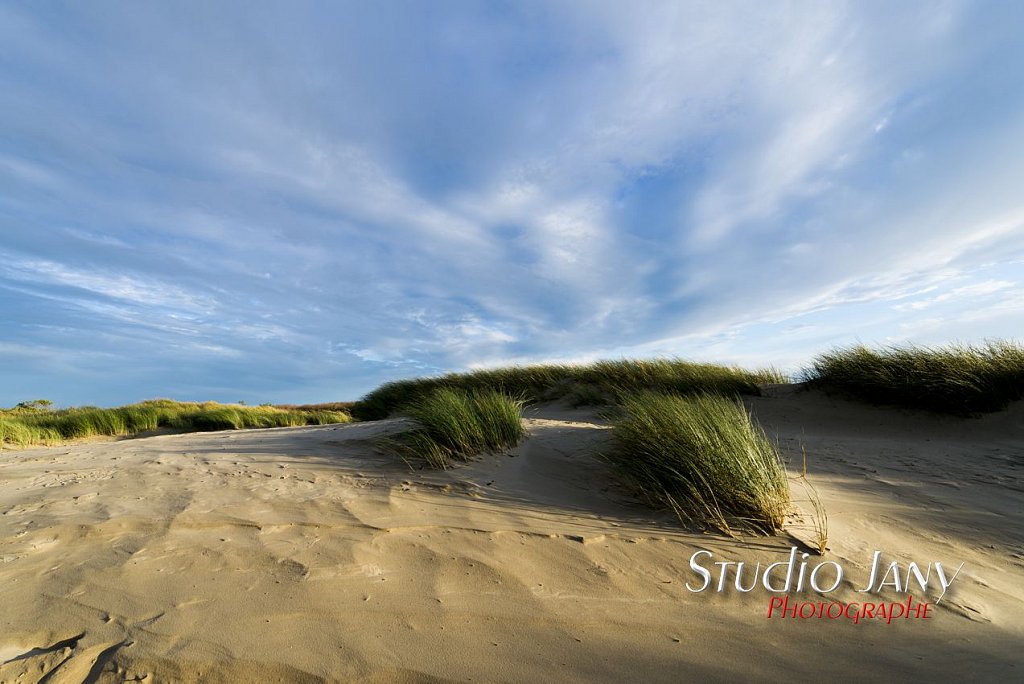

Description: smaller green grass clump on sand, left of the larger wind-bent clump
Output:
[382,387,525,469]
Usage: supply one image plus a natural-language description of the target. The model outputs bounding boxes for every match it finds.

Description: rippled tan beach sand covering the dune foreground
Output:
[0,388,1024,682]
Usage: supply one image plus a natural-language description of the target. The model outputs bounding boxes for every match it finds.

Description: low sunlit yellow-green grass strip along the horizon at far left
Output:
[0,399,351,446]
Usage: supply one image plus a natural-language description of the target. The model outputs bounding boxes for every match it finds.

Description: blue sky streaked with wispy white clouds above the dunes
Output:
[0,0,1024,405]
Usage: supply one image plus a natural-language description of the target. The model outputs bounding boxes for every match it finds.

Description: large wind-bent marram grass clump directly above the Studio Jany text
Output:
[605,392,791,535]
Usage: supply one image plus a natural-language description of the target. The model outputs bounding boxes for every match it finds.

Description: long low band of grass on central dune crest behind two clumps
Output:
[352,358,786,420]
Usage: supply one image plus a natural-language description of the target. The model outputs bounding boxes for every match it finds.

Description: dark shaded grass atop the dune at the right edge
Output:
[804,341,1024,415]
